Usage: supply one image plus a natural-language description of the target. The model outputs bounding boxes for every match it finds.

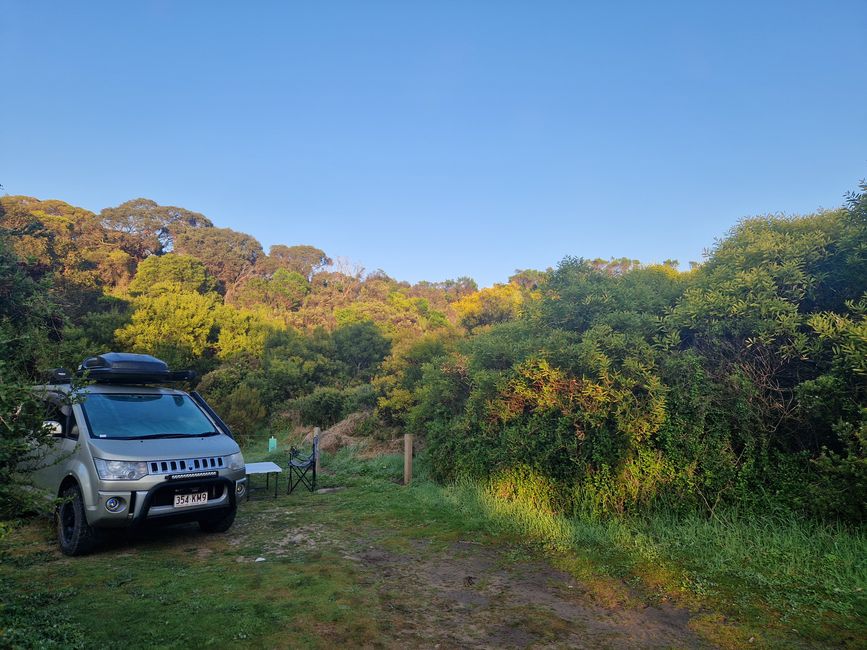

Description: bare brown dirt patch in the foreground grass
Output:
[336,542,707,649]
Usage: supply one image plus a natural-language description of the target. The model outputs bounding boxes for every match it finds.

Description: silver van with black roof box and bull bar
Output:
[33,352,246,555]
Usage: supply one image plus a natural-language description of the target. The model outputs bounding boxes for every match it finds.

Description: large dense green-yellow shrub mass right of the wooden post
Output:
[418,185,867,522]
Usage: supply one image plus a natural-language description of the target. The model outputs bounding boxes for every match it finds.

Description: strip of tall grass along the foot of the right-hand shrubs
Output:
[406,456,867,630]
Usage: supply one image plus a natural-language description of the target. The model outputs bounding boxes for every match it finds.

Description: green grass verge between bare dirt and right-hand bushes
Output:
[451,476,867,645]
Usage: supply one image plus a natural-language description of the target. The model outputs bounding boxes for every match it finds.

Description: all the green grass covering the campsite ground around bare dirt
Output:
[0,446,867,648]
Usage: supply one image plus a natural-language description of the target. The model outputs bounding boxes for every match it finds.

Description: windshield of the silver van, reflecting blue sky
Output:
[82,394,217,439]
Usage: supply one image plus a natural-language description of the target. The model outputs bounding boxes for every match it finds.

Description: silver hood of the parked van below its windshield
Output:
[90,434,241,461]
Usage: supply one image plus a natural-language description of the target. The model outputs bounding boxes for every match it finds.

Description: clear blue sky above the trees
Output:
[0,0,867,285]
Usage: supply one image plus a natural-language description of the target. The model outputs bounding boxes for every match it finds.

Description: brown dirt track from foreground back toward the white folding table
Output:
[215,494,710,650]
